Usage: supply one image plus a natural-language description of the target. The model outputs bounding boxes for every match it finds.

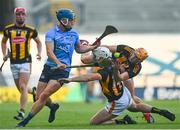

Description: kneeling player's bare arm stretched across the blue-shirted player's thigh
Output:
[58,73,102,84]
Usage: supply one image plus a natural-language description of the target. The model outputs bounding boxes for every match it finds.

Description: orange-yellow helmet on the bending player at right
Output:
[135,48,148,62]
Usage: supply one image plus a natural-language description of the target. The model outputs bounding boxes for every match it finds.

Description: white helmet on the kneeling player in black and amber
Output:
[92,47,112,67]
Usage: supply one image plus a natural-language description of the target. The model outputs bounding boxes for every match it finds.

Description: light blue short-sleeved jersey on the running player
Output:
[45,26,80,71]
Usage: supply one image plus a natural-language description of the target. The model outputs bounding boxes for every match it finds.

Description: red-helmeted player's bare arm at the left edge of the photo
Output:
[1,36,8,61]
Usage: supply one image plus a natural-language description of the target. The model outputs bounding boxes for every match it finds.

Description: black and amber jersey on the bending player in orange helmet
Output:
[116,45,142,78]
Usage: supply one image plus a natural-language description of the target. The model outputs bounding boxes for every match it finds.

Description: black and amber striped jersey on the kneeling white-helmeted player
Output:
[98,66,123,102]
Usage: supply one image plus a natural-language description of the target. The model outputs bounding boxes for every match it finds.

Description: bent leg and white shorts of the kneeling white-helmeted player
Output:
[90,87,135,125]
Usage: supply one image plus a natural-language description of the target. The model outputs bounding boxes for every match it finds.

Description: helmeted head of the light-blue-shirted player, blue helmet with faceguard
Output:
[56,9,75,31]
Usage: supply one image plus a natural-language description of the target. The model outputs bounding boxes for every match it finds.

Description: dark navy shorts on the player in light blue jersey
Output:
[39,64,69,83]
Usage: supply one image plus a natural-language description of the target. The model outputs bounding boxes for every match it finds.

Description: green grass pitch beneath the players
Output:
[0,100,180,129]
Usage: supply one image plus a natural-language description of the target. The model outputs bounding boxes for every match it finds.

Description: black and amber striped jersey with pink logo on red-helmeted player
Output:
[3,24,38,64]
